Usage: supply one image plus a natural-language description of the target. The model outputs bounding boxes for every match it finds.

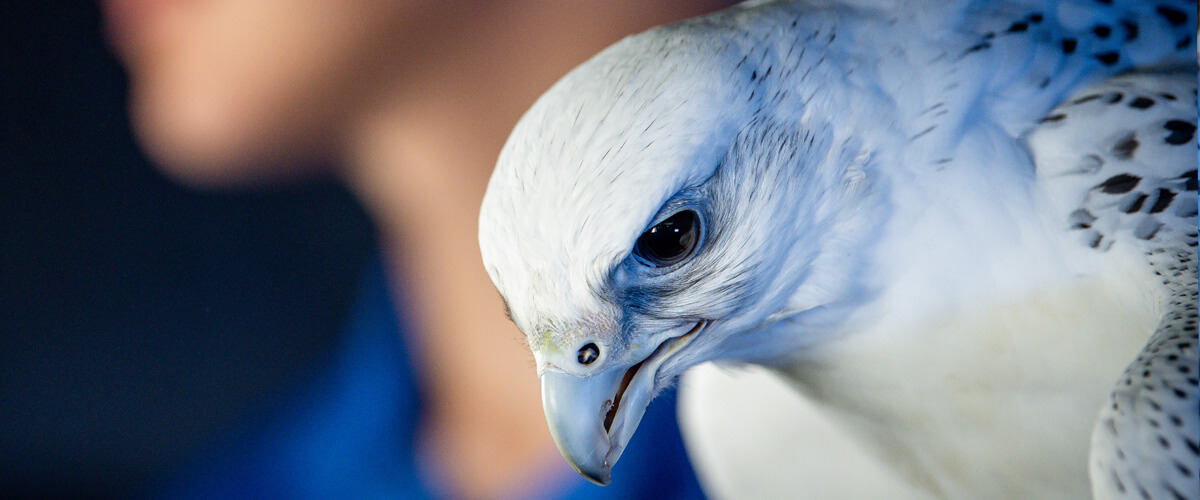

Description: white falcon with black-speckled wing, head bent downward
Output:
[480,0,1200,499]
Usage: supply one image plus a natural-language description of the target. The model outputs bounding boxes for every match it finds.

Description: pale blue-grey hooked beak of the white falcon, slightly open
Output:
[541,320,707,486]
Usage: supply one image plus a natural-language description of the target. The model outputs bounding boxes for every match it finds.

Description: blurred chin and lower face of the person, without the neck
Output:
[102,0,441,183]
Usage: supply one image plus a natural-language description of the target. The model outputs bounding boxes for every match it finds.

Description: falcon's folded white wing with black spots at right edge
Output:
[1028,67,1200,499]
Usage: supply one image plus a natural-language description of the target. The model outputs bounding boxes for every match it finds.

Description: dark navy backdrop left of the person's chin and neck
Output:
[0,0,374,498]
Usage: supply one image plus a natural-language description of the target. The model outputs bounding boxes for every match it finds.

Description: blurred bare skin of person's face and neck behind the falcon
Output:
[103,0,713,498]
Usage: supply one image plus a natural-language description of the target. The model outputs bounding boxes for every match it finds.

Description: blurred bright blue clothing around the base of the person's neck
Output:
[154,258,703,500]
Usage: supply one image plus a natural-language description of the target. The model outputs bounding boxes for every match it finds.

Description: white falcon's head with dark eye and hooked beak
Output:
[480,16,872,484]
